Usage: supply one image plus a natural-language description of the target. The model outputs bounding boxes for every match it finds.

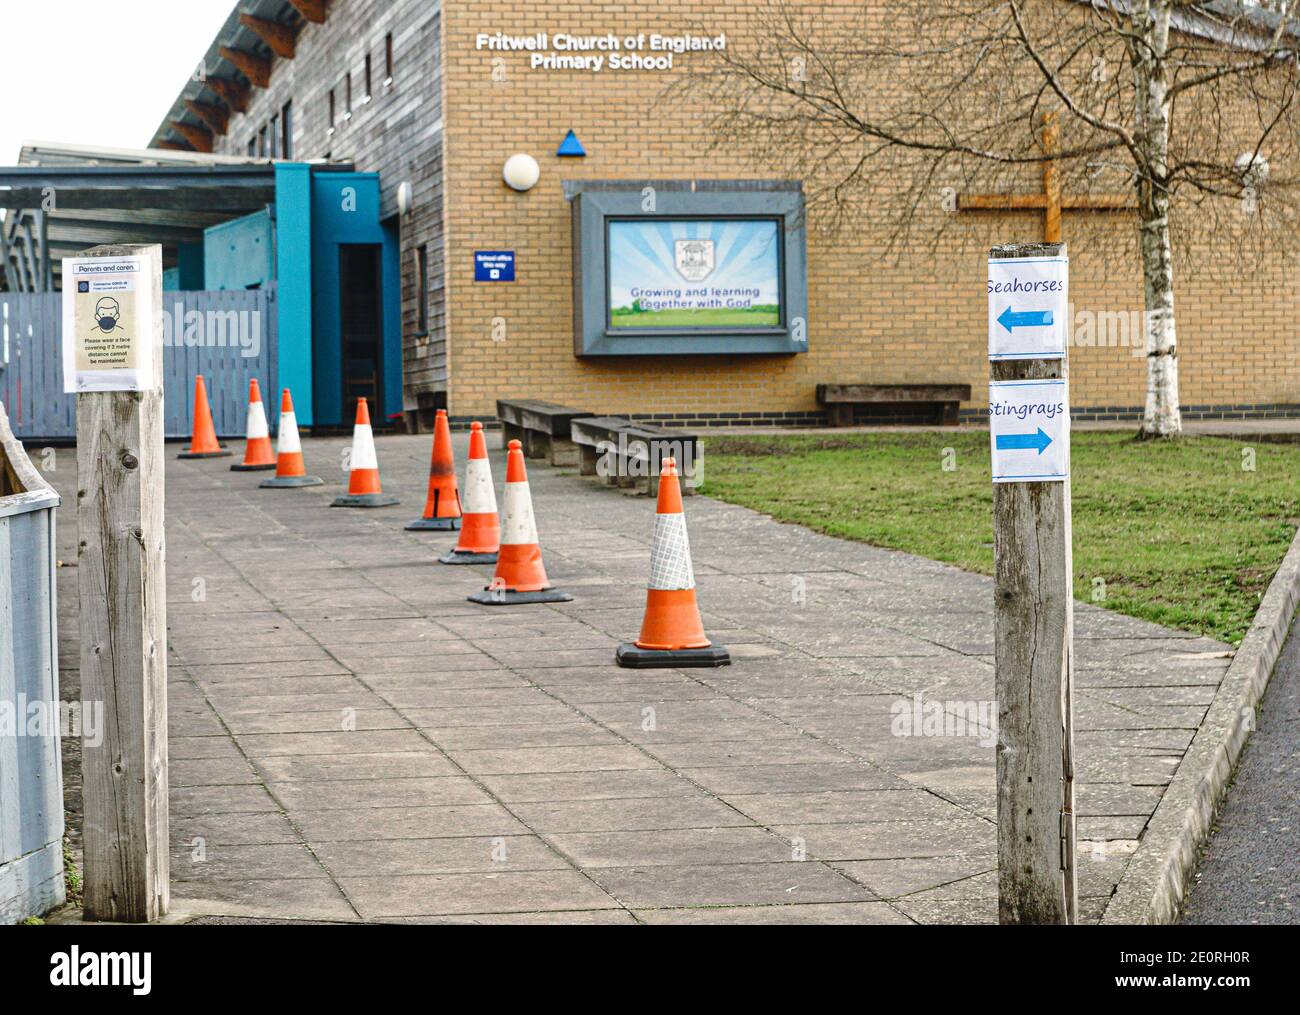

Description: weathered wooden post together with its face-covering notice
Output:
[62,246,169,923]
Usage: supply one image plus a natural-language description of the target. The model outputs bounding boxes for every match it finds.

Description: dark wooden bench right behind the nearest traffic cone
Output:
[571,416,699,495]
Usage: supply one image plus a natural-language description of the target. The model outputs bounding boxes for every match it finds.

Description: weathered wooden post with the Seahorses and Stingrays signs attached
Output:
[988,243,1078,924]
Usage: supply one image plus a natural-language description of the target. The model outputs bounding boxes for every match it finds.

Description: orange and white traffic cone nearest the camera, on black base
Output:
[614,457,731,669]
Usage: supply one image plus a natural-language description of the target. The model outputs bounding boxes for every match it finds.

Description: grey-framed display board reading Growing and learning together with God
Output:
[564,179,810,356]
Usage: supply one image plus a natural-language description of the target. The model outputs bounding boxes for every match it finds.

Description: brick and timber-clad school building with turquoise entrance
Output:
[0,0,1300,429]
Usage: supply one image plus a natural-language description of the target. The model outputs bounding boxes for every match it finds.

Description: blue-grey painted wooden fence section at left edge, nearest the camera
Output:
[0,405,64,924]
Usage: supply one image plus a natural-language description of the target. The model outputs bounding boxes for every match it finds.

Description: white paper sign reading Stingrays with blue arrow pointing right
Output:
[988,381,1070,483]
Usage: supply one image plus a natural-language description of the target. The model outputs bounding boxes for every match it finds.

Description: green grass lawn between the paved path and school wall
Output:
[702,431,1300,645]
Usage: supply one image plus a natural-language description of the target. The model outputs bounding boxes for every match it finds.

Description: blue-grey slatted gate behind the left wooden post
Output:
[0,286,280,441]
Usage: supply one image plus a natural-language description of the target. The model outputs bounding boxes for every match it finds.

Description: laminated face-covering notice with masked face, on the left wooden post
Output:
[64,257,160,392]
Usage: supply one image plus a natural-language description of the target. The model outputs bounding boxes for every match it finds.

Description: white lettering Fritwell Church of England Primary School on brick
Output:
[475,31,727,74]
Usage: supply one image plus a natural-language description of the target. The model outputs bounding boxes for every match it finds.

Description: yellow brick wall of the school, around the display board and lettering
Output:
[443,0,1300,416]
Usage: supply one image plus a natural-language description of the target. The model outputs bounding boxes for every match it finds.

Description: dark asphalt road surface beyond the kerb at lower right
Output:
[1183,605,1300,924]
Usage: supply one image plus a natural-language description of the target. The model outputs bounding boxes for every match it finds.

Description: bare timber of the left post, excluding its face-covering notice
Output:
[77,246,169,923]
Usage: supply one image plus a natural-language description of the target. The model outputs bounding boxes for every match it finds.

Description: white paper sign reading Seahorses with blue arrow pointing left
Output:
[988,255,1070,360]
